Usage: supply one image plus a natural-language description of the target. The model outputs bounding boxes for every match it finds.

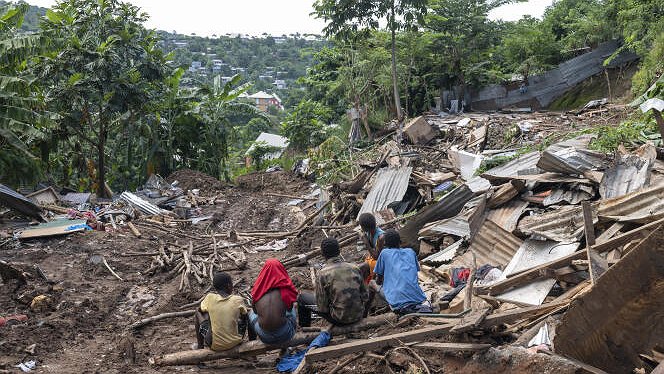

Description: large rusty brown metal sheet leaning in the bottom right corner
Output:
[554,226,664,373]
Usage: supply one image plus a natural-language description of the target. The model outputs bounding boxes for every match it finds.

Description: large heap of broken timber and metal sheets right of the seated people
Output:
[298,106,664,372]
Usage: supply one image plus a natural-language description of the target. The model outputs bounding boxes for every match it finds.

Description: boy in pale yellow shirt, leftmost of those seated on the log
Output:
[195,272,252,351]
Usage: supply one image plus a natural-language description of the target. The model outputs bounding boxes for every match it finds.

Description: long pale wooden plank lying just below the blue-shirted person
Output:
[305,324,454,362]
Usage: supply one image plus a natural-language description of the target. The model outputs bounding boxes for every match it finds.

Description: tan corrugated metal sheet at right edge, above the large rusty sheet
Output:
[598,184,664,223]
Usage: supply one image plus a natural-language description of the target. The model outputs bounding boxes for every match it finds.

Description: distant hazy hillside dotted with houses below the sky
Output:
[0,0,327,108]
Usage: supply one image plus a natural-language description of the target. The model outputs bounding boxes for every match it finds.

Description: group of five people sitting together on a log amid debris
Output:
[195,214,432,351]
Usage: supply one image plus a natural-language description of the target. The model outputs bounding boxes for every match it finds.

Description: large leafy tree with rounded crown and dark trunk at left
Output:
[39,0,166,196]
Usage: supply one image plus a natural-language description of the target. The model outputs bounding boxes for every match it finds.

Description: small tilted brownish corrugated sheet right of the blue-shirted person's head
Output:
[455,220,523,267]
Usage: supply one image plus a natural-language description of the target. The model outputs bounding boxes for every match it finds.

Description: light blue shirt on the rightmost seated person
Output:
[374,248,427,309]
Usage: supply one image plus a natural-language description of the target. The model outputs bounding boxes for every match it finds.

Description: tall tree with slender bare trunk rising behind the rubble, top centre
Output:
[314,0,427,120]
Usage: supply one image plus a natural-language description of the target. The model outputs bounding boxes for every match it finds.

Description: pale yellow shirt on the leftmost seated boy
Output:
[201,293,247,351]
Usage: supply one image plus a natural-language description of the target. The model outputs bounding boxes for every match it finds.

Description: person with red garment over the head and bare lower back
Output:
[249,258,297,344]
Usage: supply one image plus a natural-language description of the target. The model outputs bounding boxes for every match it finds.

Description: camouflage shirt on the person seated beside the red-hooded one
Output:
[316,257,369,323]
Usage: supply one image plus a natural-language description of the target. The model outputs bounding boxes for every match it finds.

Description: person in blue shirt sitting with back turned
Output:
[374,230,433,315]
